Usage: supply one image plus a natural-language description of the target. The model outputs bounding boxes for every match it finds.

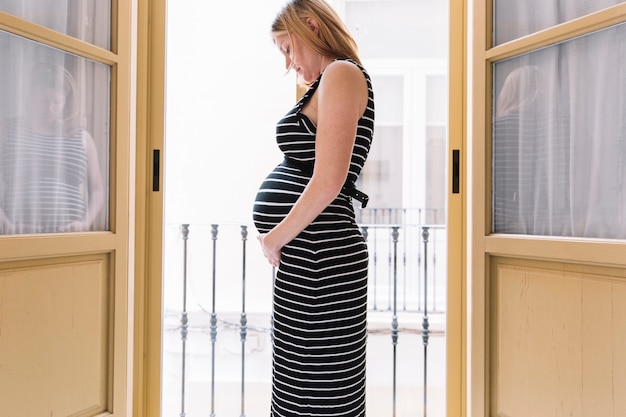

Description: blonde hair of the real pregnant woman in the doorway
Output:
[272,0,361,64]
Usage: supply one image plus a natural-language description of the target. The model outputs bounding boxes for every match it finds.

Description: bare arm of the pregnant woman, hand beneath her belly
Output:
[259,61,368,266]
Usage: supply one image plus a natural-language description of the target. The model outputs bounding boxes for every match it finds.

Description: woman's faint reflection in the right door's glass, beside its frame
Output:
[493,65,571,236]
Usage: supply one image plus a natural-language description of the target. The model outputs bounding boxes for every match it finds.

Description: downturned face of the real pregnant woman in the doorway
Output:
[274,33,323,83]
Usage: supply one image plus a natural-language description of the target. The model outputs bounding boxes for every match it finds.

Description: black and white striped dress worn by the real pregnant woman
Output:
[253,59,374,417]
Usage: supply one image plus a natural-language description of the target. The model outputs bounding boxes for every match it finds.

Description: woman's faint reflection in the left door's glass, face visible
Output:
[0,64,104,234]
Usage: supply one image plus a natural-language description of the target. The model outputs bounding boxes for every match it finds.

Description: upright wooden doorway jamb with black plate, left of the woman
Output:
[132,0,166,417]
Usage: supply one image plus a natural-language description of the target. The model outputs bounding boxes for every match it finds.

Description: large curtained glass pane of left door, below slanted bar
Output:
[0,31,110,234]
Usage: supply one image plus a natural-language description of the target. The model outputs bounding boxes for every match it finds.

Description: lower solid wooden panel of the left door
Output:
[0,255,109,416]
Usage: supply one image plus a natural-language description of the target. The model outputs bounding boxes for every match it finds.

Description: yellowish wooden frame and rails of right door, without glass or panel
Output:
[464,0,626,417]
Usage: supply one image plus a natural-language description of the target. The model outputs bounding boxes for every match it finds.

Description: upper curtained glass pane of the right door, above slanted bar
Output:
[493,0,622,45]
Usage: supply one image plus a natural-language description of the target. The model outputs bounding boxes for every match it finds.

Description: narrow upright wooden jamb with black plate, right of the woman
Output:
[446,0,469,417]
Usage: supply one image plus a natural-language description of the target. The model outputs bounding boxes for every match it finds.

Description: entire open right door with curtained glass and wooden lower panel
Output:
[468,0,626,417]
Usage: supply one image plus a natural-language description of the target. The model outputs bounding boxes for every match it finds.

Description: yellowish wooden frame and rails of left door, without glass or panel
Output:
[0,1,136,416]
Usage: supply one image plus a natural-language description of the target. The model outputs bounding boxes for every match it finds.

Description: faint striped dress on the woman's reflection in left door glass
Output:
[0,119,87,233]
